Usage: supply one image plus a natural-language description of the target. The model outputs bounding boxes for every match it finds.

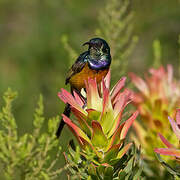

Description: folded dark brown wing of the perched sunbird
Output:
[66,51,88,84]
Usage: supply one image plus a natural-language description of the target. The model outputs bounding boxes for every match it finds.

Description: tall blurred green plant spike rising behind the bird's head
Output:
[96,0,138,79]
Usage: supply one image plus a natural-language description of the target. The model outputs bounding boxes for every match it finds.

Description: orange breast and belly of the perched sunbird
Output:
[69,63,109,90]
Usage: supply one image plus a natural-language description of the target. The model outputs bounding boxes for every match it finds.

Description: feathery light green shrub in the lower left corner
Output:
[0,89,63,180]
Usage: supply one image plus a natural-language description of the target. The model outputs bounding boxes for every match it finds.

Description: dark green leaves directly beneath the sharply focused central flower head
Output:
[65,141,142,180]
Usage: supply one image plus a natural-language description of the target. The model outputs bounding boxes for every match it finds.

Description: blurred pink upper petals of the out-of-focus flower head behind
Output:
[129,65,180,109]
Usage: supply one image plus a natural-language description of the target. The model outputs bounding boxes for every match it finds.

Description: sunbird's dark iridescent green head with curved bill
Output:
[83,38,110,60]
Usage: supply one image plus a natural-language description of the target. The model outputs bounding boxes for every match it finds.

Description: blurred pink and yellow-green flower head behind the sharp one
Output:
[130,65,180,159]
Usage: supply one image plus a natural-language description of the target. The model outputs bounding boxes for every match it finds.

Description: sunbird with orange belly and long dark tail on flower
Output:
[56,38,111,138]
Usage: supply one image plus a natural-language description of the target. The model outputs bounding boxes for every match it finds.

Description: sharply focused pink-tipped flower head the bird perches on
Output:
[58,73,138,165]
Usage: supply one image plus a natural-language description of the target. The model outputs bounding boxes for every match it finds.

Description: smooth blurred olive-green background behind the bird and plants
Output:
[0,0,180,177]
